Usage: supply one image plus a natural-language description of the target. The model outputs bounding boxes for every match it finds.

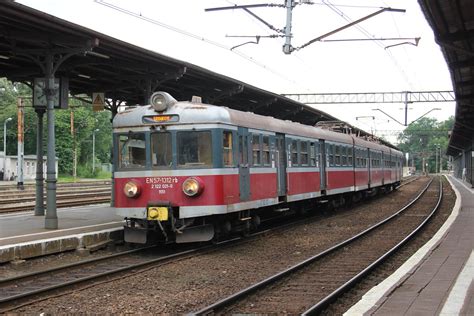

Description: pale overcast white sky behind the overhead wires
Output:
[18,0,454,141]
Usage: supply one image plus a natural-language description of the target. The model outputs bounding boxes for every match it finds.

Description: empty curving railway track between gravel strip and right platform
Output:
[193,177,442,315]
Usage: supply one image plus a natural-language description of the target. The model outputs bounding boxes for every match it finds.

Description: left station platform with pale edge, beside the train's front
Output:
[0,204,123,263]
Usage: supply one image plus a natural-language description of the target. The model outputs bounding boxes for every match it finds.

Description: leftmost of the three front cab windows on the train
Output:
[118,133,146,169]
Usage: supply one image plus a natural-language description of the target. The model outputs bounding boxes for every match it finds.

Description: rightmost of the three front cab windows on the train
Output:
[177,131,212,168]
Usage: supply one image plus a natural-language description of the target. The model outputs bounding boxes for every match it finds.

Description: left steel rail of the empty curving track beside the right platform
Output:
[190,179,433,315]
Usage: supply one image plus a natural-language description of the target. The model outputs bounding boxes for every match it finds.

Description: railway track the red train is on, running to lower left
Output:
[0,177,428,313]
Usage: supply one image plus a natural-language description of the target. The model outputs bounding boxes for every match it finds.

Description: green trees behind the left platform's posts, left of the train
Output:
[0,78,112,177]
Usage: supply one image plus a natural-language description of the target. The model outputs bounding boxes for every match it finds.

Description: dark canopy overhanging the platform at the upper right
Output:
[418,0,474,156]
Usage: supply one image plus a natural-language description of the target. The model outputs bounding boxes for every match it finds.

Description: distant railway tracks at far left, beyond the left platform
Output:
[0,181,111,213]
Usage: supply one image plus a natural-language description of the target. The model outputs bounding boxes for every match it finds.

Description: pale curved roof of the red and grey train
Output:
[113,101,400,152]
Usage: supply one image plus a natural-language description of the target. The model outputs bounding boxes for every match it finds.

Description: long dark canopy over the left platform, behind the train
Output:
[0,1,337,125]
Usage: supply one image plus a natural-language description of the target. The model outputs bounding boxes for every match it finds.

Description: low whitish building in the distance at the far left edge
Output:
[0,151,58,181]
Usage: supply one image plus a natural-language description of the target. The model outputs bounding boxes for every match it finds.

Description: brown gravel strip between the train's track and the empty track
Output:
[2,175,454,314]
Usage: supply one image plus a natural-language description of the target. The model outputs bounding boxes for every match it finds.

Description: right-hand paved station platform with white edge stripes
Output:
[344,176,474,315]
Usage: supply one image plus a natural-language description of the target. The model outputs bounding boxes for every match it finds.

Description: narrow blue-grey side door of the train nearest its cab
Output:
[238,127,250,201]
